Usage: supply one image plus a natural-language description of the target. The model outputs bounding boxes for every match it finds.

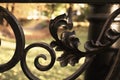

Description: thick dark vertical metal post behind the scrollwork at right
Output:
[85,4,112,80]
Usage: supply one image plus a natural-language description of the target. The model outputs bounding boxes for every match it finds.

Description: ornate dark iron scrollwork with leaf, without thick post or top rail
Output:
[0,7,120,80]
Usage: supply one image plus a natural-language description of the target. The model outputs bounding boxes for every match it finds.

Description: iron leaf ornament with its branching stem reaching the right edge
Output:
[49,8,120,80]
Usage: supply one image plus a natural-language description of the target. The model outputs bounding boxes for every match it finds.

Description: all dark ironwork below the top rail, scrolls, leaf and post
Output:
[0,4,120,80]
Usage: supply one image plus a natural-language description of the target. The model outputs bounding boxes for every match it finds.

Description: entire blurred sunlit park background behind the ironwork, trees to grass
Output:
[0,3,119,80]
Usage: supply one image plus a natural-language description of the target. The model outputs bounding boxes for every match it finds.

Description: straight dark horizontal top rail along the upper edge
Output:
[0,0,120,4]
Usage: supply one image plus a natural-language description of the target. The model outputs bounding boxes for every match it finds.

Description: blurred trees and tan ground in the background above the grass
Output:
[0,3,89,39]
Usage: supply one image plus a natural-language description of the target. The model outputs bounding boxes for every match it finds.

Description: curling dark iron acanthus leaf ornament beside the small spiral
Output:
[49,14,84,66]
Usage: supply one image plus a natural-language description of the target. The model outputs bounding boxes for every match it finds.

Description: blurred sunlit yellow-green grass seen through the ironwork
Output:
[0,27,88,80]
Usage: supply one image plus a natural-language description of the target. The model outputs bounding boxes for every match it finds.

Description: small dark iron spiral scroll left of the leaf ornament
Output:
[21,42,56,80]
